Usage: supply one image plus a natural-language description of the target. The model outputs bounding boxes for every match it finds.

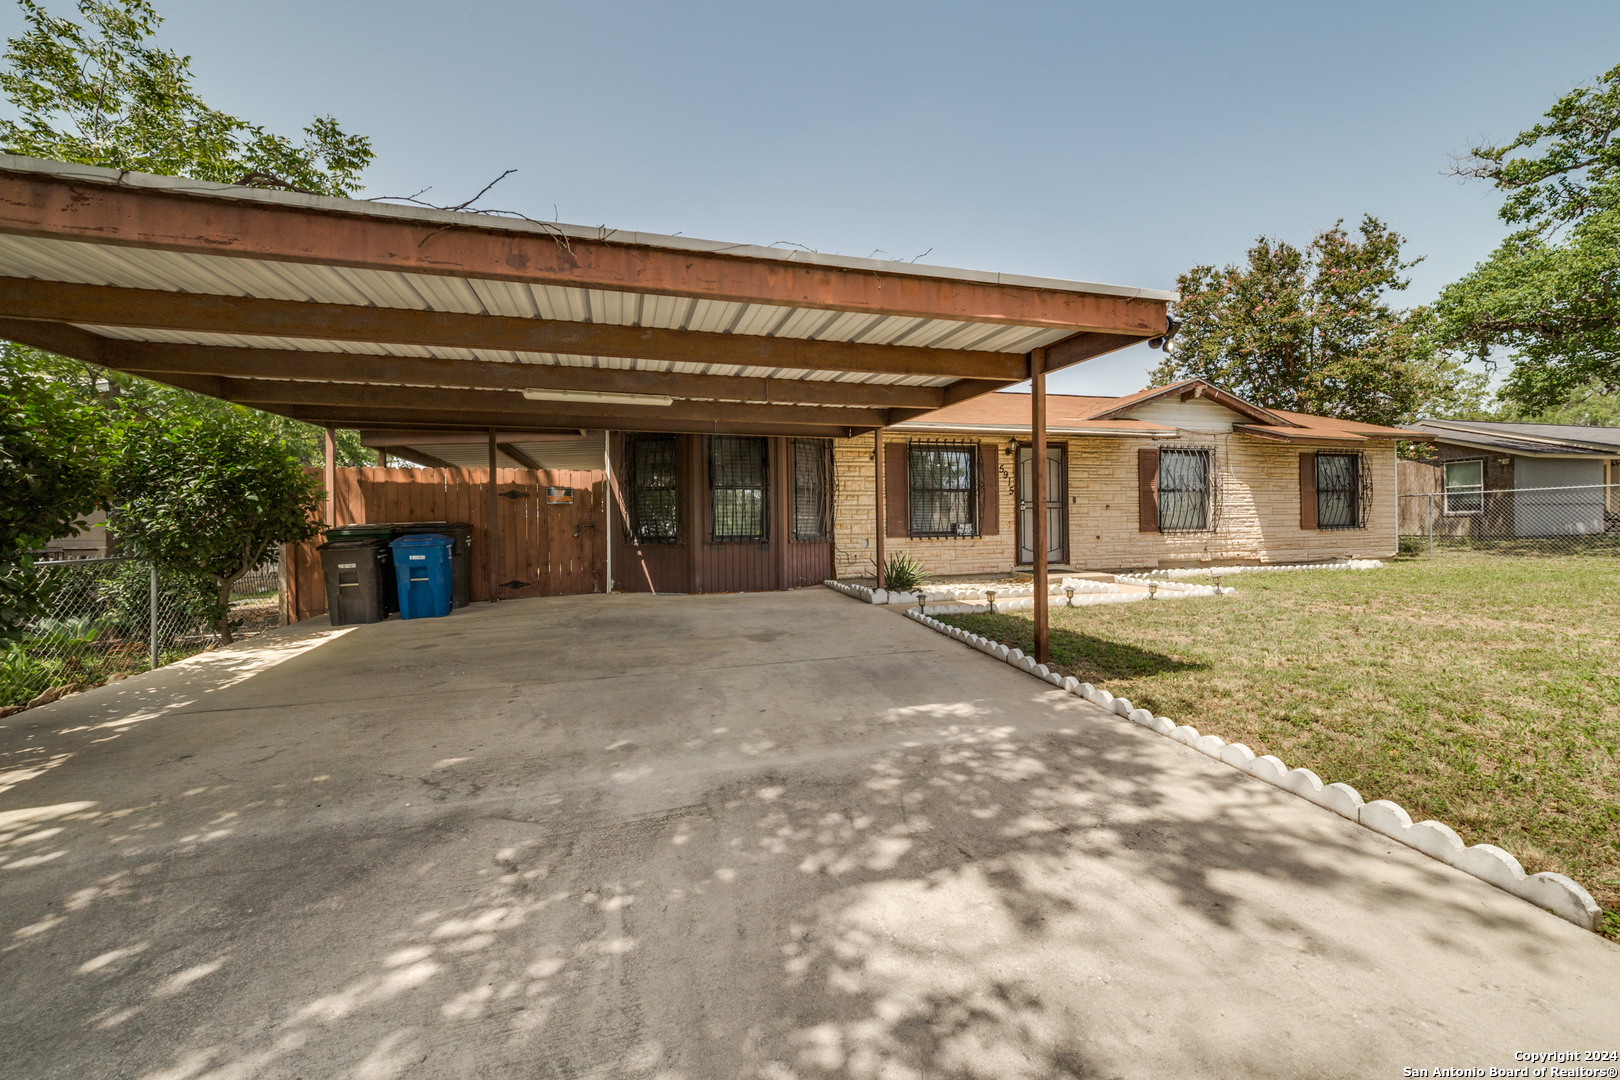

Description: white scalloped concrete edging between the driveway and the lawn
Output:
[900,605,1604,933]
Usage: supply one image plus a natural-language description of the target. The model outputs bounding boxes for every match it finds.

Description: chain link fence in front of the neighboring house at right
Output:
[1400,484,1620,555]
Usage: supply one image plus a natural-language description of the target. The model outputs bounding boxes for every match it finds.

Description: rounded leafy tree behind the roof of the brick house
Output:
[1152,215,1484,424]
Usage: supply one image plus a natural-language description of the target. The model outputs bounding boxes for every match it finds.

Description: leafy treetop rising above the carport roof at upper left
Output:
[0,0,374,196]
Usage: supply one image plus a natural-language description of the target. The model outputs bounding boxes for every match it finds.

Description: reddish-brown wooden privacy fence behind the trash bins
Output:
[282,468,608,622]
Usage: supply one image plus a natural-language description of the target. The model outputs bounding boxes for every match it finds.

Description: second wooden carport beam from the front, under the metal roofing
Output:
[0,277,1025,379]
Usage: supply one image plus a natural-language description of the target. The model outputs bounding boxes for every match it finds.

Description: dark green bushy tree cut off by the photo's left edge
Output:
[0,363,113,636]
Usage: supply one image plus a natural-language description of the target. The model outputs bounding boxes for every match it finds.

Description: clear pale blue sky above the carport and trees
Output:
[0,0,1620,393]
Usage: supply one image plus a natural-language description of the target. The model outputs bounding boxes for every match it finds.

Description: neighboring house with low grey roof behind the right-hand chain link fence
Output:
[1400,419,1620,538]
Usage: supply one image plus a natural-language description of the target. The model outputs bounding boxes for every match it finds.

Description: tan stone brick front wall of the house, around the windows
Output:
[833,432,1398,578]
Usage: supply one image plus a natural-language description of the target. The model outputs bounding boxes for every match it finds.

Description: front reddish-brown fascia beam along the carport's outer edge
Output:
[0,170,1165,333]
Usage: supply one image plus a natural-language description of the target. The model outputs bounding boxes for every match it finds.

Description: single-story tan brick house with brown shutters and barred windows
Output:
[611,379,1416,591]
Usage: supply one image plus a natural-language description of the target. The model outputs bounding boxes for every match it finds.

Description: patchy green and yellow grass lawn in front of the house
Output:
[943,554,1620,938]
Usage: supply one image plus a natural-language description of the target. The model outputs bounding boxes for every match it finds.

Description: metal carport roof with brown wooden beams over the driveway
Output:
[0,155,1175,436]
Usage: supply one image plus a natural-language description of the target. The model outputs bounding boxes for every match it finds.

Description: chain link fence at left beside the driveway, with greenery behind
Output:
[0,559,280,706]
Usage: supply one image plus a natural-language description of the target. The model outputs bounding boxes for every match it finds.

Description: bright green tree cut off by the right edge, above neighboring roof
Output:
[1435,65,1620,411]
